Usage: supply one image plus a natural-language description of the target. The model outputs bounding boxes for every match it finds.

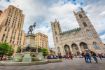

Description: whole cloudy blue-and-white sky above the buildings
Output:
[0,0,105,47]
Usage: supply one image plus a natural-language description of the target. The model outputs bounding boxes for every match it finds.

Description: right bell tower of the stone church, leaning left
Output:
[74,8,99,39]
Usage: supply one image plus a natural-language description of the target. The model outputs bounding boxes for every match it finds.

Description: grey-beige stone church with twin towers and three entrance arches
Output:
[51,9,104,55]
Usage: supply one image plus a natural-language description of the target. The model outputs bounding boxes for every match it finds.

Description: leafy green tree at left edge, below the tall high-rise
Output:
[0,43,14,60]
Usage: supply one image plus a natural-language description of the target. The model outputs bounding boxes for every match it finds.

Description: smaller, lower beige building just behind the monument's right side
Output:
[35,32,48,49]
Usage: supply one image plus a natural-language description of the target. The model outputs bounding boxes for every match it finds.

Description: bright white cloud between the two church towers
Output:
[49,3,78,31]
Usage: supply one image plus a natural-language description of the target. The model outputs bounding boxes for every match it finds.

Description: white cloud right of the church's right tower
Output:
[85,3,105,43]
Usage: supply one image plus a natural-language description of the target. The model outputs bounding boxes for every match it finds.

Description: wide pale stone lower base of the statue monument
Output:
[13,52,44,62]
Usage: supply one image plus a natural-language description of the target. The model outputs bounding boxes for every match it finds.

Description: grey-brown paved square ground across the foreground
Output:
[0,58,105,70]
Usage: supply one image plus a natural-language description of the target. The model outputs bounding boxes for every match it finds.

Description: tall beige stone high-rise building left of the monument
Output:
[0,5,25,51]
